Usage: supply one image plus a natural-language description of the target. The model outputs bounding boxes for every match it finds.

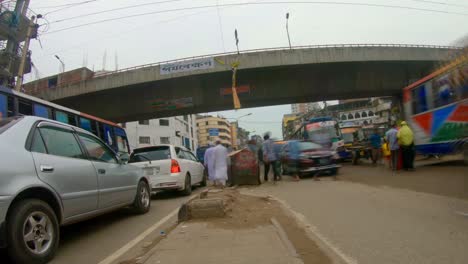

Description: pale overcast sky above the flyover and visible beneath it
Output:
[27,0,468,137]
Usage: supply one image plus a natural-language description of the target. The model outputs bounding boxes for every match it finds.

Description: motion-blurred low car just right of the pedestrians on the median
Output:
[280,140,341,177]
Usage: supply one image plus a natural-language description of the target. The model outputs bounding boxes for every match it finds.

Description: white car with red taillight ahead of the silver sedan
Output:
[129,145,206,195]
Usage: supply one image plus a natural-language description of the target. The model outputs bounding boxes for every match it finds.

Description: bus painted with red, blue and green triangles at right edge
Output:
[403,56,468,162]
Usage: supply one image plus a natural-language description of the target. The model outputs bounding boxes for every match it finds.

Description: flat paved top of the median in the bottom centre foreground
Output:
[144,222,302,264]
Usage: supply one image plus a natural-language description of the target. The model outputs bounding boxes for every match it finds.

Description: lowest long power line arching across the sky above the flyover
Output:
[46,0,468,34]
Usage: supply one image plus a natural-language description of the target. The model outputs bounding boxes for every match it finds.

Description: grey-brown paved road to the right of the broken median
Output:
[250,164,468,264]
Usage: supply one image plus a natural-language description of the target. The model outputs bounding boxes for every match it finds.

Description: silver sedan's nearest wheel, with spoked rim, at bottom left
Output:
[7,199,60,264]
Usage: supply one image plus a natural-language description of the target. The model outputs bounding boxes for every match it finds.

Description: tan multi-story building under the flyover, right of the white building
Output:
[197,116,233,147]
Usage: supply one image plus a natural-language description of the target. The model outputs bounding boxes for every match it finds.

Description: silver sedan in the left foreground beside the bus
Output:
[0,116,151,263]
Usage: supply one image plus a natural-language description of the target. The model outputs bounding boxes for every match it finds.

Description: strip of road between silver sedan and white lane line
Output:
[0,188,201,264]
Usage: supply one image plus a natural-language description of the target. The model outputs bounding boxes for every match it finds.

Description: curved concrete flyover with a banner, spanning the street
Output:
[26,44,460,122]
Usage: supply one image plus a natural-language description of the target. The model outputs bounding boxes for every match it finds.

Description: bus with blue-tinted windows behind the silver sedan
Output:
[0,86,130,154]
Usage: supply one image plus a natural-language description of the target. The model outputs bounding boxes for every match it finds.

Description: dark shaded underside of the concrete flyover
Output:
[54,61,437,122]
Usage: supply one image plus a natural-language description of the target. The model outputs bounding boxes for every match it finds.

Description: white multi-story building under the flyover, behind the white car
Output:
[122,115,198,151]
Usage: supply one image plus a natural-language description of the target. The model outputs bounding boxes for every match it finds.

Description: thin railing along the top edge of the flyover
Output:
[94,44,462,78]
